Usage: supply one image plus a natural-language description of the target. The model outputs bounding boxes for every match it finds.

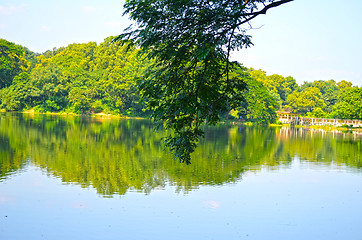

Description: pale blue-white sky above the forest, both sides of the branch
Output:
[0,0,362,86]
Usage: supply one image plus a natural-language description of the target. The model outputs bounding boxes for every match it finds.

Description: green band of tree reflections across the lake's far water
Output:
[0,113,362,196]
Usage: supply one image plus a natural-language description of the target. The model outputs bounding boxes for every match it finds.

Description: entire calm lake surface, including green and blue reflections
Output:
[0,113,362,240]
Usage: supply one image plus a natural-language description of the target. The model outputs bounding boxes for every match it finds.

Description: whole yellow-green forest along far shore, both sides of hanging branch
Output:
[0,37,362,122]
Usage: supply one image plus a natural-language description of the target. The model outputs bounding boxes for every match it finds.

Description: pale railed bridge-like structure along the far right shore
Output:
[277,112,362,127]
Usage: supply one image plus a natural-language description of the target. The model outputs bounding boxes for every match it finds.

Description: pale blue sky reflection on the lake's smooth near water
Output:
[0,158,362,240]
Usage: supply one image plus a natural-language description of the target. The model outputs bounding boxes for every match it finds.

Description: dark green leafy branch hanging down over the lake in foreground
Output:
[117,0,293,163]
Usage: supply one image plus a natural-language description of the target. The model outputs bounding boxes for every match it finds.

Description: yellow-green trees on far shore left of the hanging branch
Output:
[0,37,150,115]
